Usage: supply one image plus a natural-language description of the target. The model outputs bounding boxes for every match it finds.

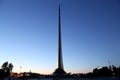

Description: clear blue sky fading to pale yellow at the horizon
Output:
[0,0,120,74]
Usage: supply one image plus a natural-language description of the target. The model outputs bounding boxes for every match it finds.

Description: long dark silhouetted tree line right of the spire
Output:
[80,65,120,77]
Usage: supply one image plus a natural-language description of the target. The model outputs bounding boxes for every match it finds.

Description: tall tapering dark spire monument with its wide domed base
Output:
[53,4,66,77]
